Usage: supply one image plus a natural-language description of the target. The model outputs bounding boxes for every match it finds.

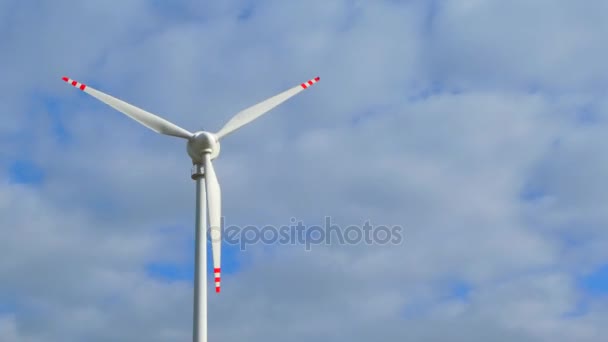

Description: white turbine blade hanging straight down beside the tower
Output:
[204,153,222,292]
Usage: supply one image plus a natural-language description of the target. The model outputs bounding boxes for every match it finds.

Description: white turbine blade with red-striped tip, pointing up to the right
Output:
[216,77,320,139]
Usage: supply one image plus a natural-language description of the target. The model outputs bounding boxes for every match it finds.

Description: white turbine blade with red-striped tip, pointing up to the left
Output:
[62,77,192,139]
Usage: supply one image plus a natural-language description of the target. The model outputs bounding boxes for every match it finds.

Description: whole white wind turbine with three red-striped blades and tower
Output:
[62,73,320,342]
